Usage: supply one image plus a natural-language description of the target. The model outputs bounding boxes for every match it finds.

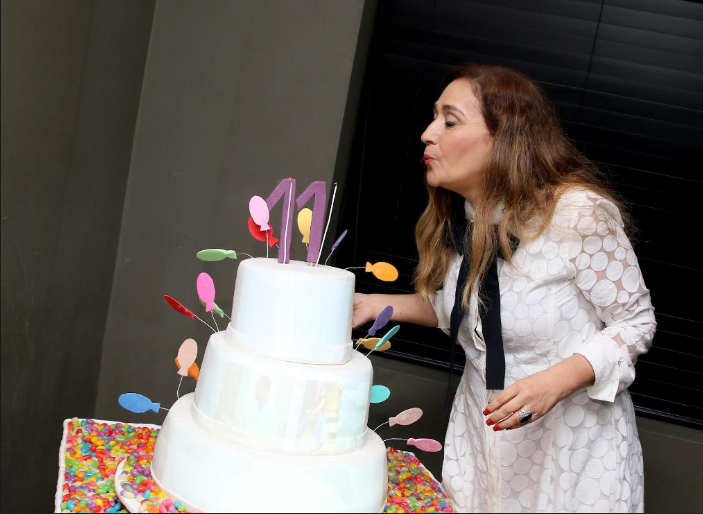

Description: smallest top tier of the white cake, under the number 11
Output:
[226,258,355,364]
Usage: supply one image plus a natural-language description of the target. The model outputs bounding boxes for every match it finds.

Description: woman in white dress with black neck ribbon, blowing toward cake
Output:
[353,65,656,512]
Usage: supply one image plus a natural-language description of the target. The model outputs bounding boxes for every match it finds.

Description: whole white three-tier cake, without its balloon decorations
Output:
[151,258,387,512]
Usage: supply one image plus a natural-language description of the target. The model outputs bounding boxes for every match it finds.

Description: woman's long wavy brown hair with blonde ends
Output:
[414,64,631,308]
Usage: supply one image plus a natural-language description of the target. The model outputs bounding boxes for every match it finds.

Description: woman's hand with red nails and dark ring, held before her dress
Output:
[483,354,595,430]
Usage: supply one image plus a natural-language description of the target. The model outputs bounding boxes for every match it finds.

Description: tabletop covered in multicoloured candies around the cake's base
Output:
[55,418,456,512]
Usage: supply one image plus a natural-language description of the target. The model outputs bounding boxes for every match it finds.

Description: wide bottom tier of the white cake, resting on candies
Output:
[151,394,388,512]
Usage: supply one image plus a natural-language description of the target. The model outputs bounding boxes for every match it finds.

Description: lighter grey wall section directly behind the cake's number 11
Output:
[95,0,375,423]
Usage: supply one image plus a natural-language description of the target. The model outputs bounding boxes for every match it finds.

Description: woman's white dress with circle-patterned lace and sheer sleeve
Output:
[432,189,656,512]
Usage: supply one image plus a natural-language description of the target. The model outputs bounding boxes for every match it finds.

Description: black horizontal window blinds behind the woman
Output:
[337,0,703,428]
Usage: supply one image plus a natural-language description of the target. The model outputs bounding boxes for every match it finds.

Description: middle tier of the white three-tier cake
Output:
[193,332,373,455]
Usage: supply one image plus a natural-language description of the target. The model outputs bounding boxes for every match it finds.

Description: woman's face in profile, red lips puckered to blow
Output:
[422,79,493,202]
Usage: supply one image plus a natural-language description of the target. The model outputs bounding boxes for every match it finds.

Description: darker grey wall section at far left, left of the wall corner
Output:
[1,0,154,512]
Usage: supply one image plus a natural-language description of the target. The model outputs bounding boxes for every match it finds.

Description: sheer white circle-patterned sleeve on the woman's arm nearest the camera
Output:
[557,193,656,402]
